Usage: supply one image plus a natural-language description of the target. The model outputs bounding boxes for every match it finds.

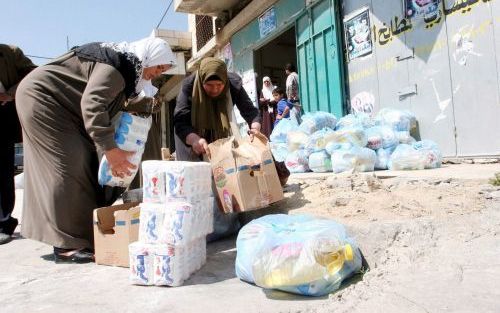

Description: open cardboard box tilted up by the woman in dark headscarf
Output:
[208,134,283,213]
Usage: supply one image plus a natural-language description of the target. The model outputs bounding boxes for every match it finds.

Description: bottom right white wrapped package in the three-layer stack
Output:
[153,237,207,286]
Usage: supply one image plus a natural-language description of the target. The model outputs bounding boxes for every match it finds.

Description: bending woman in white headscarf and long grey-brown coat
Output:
[16,38,175,263]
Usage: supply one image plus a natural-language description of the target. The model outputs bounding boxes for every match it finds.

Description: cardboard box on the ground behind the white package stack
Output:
[94,202,140,267]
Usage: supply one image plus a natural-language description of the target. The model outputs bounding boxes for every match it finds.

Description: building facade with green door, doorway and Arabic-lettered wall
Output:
[175,0,500,157]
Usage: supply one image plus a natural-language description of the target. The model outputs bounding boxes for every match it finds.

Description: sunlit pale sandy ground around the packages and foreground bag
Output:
[0,164,500,312]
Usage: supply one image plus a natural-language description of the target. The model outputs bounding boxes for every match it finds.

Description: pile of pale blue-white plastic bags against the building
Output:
[270,108,442,173]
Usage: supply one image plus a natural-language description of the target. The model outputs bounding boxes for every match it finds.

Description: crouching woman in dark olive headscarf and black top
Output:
[174,58,261,161]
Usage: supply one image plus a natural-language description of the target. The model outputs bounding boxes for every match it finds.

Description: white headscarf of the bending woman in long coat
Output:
[103,37,177,97]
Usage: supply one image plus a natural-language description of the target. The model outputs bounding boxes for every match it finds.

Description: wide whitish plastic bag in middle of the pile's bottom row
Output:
[332,145,377,173]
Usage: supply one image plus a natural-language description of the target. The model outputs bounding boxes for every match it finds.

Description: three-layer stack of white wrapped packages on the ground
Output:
[129,161,214,286]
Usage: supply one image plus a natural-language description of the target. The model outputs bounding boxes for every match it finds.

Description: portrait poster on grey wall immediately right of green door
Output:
[344,7,373,61]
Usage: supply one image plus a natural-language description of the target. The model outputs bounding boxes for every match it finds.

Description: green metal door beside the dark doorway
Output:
[296,0,344,117]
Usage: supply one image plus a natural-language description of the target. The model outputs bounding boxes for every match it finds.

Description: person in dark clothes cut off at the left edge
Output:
[0,44,36,244]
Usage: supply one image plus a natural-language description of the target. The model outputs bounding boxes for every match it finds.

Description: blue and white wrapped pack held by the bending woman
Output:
[98,112,152,187]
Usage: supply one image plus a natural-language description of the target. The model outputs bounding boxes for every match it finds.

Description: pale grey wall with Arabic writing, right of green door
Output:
[342,0,500,156]
